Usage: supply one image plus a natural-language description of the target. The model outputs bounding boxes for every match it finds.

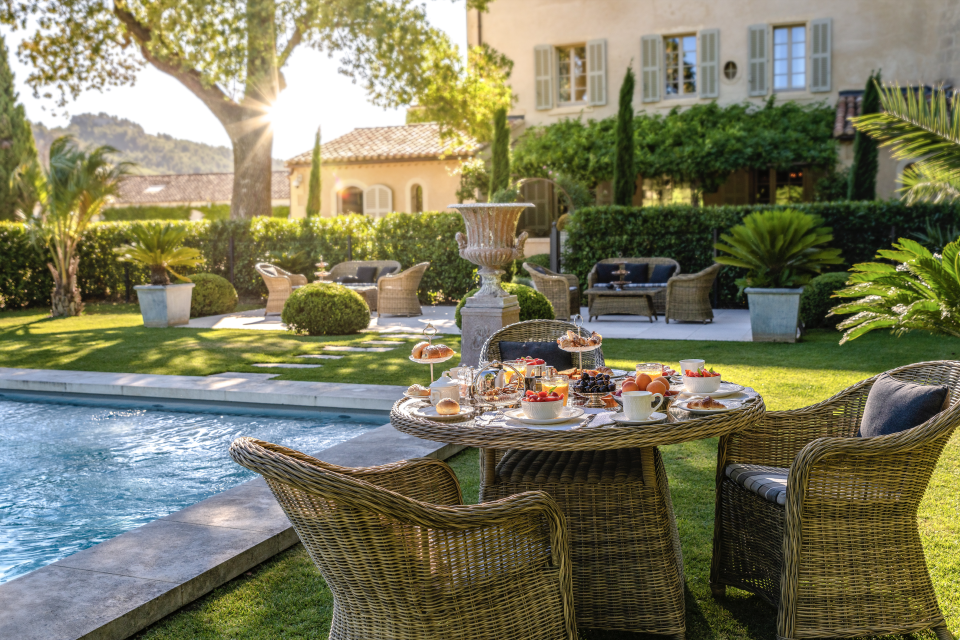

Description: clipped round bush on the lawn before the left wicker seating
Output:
[280,282,370,336]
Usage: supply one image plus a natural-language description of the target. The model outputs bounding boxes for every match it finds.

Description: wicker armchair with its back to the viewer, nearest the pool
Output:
[230,438,576,640]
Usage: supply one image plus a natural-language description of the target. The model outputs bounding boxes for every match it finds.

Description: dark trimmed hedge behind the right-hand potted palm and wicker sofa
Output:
[562,201,960,307]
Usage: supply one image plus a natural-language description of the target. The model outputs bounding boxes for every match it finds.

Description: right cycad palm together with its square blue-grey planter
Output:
[715,209,842,342]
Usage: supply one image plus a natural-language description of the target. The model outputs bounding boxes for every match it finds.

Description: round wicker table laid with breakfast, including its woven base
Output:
[390,387,765,638]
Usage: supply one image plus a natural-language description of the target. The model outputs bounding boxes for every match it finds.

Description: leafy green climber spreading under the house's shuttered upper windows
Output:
[513,98,837,193]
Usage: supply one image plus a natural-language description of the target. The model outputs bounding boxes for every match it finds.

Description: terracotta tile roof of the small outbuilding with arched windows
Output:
[286,122,480,166]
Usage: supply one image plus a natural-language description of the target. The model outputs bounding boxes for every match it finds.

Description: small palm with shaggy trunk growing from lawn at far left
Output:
[11,136,132,317]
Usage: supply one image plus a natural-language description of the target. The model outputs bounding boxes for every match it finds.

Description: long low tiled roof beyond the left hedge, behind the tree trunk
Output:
[113,171,290,205]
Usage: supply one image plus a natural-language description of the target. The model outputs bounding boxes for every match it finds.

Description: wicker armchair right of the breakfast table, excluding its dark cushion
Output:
[710,361,960,640]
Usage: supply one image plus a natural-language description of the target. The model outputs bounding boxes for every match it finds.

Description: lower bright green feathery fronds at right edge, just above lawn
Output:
[831,238,960,344]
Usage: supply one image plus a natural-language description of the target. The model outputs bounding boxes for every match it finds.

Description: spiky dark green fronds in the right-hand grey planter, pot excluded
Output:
[714,209,843,292]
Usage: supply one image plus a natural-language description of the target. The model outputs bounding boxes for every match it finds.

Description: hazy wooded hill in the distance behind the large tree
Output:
[32,113,283,175]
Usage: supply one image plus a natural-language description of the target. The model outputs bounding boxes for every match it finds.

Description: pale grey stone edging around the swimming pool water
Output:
[0,369,464,640]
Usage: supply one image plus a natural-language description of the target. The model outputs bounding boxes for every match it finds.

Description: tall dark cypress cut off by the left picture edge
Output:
[0,36,37,220]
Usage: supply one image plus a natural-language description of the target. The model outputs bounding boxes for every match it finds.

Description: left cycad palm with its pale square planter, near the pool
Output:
[114,222,203,327]
